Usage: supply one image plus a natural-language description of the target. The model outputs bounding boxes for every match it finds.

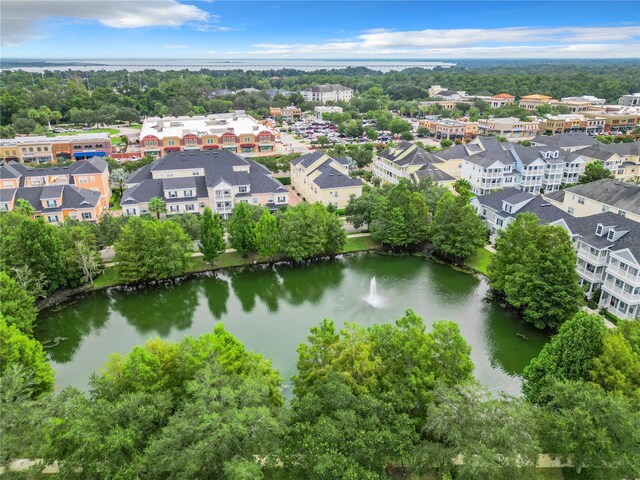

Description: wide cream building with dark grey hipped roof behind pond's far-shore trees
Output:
[120,149,289,218]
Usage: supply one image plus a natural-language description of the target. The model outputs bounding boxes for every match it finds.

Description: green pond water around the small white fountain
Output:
[36,254,547,394]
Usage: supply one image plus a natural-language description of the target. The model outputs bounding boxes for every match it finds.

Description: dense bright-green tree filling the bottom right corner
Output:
[542,381,640,480]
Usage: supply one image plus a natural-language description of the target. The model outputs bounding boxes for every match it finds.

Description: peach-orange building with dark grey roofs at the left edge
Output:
[0,157,111,224]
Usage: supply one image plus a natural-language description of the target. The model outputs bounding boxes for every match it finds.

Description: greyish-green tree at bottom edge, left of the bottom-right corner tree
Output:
[416,383,541,480]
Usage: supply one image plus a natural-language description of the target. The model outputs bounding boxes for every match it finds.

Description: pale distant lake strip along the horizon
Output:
[2,59,456,73]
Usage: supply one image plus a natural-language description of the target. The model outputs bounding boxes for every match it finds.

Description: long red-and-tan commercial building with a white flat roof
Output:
[140,110,278,157]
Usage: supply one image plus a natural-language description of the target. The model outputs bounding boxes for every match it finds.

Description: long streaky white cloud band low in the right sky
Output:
[234,25,640,59]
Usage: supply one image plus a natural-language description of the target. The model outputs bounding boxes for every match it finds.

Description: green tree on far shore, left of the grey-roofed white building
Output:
[431,192,487,259]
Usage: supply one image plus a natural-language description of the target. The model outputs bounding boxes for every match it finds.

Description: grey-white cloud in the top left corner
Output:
[0,0,210,46]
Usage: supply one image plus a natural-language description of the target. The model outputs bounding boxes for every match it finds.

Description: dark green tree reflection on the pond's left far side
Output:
[113,282,198,336]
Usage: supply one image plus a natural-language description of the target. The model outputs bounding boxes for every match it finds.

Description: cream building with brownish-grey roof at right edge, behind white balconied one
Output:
[545,178,640,223]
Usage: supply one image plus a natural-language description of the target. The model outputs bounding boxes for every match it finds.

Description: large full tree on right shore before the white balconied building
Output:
[489,213,583,328]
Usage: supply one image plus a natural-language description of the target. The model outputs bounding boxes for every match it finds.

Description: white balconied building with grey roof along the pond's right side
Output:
[471,188,640,320]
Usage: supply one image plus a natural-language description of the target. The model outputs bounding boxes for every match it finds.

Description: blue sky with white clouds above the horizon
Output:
[0,0,640,60]
